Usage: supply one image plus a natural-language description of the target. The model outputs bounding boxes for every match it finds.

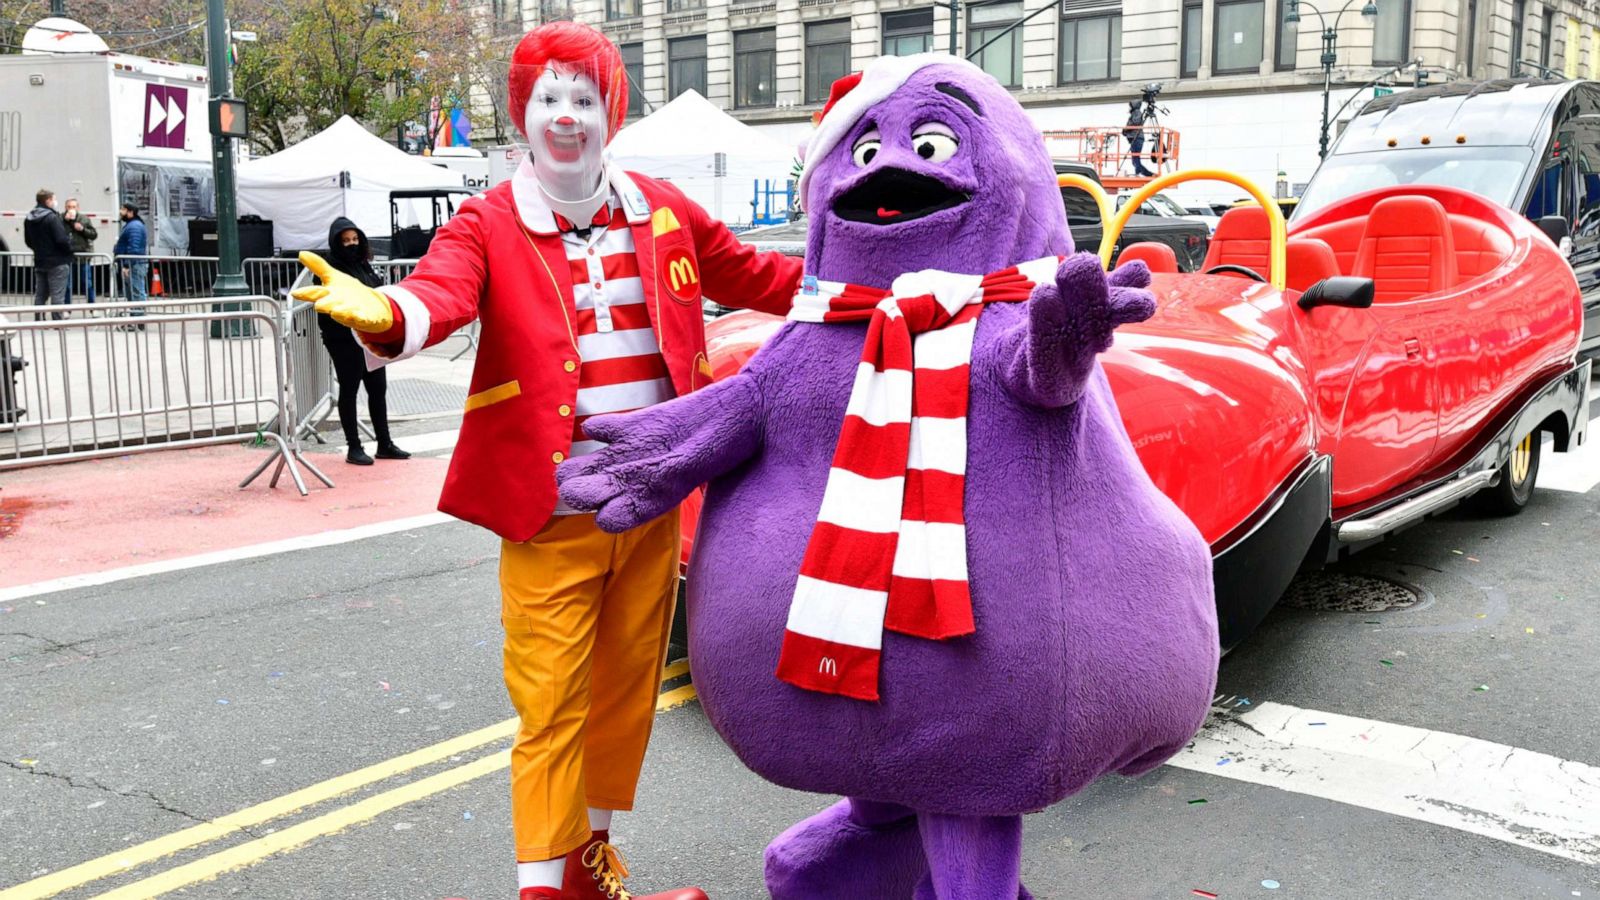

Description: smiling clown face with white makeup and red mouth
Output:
[523,66,606,202]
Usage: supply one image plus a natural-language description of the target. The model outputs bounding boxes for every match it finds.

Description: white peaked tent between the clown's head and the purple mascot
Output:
[608,90,795,223]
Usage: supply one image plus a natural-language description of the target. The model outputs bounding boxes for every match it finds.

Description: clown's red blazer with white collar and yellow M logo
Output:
[373,171,802,541]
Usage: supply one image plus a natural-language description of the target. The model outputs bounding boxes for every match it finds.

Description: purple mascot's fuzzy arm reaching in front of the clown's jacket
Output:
[555,372,762,533]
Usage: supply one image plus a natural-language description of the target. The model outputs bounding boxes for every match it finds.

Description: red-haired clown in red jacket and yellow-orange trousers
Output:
[298,22,800,900]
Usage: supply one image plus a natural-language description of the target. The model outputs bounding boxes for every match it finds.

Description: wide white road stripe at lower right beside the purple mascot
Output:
[1170,703,1600,865]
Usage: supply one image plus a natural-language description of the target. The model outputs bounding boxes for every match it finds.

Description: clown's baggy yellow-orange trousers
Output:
[501,511,678,862]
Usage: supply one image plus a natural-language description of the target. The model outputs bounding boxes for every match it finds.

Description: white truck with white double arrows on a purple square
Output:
[0,26,216,255]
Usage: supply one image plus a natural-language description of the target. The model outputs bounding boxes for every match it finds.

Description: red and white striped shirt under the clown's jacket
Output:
[555,194,677,516]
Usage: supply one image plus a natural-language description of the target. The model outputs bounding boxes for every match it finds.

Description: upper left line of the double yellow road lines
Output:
[0,717,517,900]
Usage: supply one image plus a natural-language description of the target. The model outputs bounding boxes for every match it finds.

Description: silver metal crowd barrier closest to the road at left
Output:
[0,296,333,496]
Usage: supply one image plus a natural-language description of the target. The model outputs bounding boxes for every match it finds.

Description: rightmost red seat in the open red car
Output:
[1352,197,1459,303]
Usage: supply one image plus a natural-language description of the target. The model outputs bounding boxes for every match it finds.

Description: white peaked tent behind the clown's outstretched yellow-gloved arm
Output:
[238,115,464,250]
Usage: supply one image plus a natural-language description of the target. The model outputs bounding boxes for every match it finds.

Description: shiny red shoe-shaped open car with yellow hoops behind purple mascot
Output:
[685,173,1589,649]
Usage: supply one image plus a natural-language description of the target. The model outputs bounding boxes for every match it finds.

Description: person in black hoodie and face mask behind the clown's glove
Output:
[317,216,411,466]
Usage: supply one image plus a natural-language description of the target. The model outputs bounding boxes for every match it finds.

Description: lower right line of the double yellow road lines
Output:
[98,753,510,900]
